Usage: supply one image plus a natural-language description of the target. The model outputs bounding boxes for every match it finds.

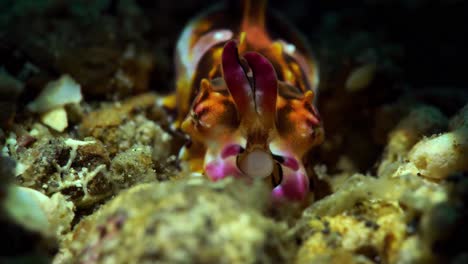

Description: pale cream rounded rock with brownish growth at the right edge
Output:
[378,102,468,180]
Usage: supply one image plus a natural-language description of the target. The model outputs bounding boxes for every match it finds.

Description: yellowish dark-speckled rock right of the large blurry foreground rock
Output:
[296,201,406,263]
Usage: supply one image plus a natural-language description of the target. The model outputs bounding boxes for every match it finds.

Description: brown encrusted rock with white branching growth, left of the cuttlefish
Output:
[2,100,177,208]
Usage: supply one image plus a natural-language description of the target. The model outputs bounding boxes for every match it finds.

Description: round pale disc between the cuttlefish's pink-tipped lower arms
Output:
[237,150,275,178]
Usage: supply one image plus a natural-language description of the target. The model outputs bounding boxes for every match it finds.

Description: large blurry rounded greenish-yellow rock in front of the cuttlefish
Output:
[55,179,293,263]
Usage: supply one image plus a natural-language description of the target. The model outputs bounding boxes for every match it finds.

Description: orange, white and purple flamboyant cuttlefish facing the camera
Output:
[166,0,324,200]
